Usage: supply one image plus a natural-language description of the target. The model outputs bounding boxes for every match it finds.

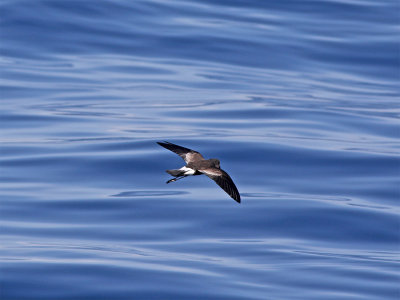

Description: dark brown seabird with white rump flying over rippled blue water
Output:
[157,141,240,203]
